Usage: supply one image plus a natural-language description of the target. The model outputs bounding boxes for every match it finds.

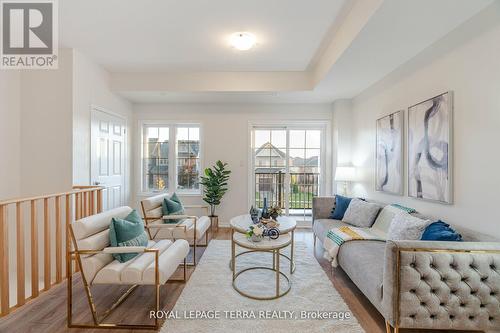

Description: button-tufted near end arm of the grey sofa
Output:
[382,241,500,332]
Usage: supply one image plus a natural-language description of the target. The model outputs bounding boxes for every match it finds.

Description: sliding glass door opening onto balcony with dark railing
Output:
[251,125,325,221]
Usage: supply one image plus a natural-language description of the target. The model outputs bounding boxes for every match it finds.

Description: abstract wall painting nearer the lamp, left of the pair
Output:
[375,111,404,195]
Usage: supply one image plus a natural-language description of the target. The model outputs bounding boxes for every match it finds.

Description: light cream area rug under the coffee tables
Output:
[161,240,364,333]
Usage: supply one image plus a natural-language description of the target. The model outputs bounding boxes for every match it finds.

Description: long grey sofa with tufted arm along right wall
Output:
[313,197,500,333]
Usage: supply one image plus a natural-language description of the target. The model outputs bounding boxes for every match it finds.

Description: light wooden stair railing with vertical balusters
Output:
[0,186,103,317]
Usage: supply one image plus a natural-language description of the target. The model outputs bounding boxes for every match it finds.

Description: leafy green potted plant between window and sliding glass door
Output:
[200,161,231,229]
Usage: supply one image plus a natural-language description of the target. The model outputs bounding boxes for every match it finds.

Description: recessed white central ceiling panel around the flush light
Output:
[59,0,346,71]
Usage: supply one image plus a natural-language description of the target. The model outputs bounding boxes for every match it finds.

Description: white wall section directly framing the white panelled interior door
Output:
[73,50,132,203]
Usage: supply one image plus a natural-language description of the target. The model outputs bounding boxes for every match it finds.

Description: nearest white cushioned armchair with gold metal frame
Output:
[66,207,189,329]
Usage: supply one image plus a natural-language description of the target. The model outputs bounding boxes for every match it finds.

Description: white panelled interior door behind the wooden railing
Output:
[91,109,126,210]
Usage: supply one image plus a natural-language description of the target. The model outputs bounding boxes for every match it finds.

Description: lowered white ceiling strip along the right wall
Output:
[314,0,493,100]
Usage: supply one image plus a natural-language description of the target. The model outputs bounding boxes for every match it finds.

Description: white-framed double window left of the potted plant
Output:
[142,124,201,193]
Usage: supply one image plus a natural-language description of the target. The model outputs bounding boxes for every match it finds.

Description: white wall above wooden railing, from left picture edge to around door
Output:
[0,49,132,203]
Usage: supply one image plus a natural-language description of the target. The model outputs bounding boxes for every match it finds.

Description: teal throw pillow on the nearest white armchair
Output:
[109,209,148,262]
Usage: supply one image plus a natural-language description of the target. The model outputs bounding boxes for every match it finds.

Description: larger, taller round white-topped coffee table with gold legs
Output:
[229,214,297,274]
